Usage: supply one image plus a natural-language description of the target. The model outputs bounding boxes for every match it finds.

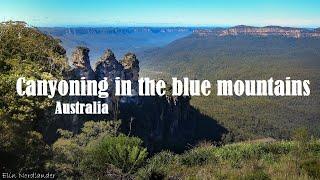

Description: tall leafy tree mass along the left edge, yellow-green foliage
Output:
[0,22,68,171]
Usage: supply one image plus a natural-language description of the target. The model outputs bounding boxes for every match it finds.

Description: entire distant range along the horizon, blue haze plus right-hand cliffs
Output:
[39,25,320,61]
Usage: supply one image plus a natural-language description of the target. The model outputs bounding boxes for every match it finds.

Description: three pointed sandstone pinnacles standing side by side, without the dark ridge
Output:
[67,47,140,121]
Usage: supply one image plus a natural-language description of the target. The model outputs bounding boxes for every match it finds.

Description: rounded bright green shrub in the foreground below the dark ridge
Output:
[85,135,148,174]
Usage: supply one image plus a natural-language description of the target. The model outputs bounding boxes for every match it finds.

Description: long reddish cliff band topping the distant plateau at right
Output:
[195,25,320,38]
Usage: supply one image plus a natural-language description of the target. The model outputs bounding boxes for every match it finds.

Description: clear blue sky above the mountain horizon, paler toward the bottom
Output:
[0,0,320,27]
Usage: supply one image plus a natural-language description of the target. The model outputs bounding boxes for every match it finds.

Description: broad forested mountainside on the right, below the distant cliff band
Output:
[141,35,320,140]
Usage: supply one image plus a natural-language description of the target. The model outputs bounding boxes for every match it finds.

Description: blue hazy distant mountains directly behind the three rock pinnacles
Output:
[39,27,195,61]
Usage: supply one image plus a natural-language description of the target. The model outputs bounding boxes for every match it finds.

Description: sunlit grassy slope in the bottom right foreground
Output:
[137,141,320,179]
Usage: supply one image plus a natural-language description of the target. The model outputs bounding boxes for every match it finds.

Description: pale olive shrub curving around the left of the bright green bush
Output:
[46,121,121,178]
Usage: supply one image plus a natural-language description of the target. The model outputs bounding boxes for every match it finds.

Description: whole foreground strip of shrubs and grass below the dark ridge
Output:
[47,121,320,179]
